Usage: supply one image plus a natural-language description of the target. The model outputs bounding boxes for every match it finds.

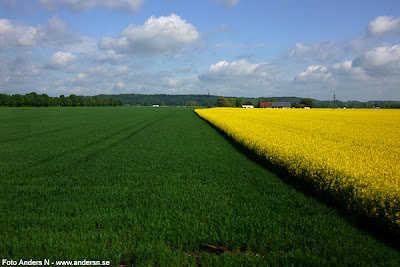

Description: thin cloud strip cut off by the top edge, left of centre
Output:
[39,0,145,12]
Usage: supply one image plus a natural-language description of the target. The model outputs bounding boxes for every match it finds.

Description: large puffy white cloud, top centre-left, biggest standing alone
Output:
[99,14,199,55]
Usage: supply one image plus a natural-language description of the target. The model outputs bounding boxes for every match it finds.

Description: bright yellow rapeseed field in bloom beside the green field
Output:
[195,108,400,227]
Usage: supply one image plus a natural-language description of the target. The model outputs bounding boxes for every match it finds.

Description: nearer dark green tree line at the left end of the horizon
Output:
[0,92,124,107]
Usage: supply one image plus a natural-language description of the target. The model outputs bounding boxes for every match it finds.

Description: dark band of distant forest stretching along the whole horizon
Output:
[0,92,400,108]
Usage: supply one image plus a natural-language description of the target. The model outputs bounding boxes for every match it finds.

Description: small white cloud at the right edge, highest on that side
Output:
[367,16,400,37]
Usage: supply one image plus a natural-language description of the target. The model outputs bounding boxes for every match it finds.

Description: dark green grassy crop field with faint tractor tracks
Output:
[0,108,400,266]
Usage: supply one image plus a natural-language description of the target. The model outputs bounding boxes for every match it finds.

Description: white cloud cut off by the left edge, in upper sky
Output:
[0,19,37,49]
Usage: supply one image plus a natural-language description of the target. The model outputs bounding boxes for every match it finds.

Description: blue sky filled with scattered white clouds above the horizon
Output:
[0,0,400,101]
